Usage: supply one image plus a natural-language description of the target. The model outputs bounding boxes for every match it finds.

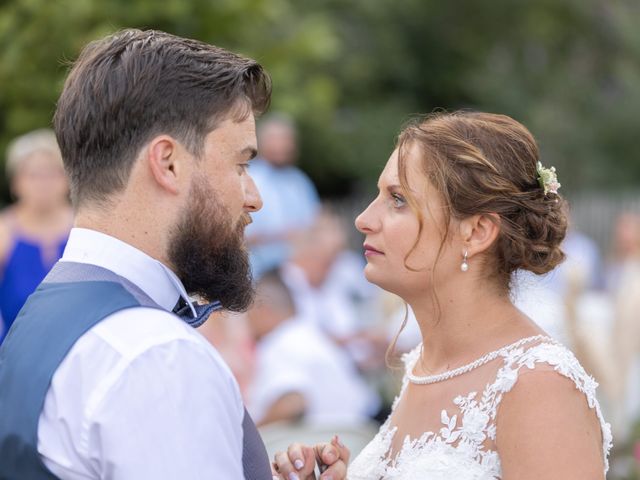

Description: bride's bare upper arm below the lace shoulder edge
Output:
[496,370,605,480]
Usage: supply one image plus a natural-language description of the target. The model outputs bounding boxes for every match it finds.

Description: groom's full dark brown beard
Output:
[168,178,253,312]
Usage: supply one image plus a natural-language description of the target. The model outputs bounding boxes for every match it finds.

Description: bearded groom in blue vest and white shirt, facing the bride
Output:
[0,30,349,480]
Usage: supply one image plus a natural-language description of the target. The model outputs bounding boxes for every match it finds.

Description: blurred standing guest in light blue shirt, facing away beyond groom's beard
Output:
[246,113,319,278]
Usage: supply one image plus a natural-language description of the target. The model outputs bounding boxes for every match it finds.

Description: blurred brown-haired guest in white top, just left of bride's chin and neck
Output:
[280,205,389,372]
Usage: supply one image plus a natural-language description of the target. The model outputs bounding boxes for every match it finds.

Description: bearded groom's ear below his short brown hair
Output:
[144,135,187,195]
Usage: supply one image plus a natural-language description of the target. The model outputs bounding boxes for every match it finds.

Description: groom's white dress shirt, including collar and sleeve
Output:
[38,228,244,480]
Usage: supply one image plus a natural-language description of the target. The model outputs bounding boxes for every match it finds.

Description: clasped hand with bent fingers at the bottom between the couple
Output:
[272,435,351,480]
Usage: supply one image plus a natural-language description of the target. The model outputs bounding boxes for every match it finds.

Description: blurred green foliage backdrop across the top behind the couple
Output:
[0,0,640,201]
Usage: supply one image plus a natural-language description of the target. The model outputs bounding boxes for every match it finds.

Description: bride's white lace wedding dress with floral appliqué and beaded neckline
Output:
[347,337,612,480]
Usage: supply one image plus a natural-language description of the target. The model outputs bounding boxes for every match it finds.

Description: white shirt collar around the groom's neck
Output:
[60,228,196,318]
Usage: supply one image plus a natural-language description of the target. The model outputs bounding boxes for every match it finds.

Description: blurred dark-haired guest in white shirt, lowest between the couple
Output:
[247,271,377,425]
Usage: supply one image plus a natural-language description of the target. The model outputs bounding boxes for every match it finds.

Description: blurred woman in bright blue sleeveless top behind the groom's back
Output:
[0,129,73,342]
